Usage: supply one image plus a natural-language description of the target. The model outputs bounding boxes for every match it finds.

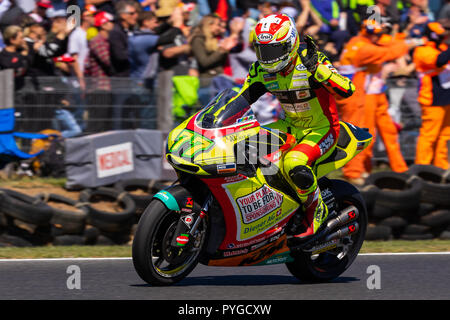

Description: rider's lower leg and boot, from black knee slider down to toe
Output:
[289,166,328,240]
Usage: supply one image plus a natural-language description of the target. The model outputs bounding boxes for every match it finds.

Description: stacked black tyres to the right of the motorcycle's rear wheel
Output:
[360,165,450,240]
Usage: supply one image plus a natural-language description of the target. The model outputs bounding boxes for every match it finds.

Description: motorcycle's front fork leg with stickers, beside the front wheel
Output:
[171,193,213,247]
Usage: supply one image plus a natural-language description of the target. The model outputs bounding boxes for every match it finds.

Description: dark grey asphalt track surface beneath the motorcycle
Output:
[0,253,450,301]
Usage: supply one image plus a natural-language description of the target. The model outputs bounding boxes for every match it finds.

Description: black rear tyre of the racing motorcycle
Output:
[286,182,367,282]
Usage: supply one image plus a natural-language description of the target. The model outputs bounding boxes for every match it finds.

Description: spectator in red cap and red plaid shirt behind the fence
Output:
[85,11,114,132]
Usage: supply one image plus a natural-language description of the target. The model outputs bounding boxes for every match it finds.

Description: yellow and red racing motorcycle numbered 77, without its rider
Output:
[132,89,372,285]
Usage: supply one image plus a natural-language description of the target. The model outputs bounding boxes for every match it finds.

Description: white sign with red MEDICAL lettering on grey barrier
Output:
[95,142,134,178]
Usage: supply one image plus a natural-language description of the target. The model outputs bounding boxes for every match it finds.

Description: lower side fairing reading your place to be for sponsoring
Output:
[202,163,299,266]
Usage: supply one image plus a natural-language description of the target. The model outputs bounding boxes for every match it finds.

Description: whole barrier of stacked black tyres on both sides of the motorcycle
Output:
[0,170,450,247]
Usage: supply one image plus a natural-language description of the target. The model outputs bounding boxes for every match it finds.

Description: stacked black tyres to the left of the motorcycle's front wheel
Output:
[0,180,166,247]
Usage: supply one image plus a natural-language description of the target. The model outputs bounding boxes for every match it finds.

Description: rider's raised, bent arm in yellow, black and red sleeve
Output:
[314,52,355,98]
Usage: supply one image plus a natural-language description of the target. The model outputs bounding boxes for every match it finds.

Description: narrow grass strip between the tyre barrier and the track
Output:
[0,240,450,259]
